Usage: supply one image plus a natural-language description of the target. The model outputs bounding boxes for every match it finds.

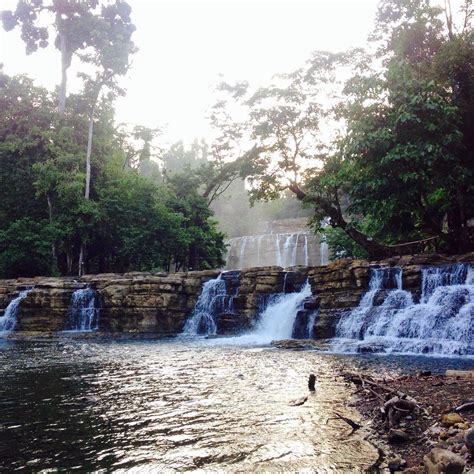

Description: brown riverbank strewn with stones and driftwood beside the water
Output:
[342,364,474,474]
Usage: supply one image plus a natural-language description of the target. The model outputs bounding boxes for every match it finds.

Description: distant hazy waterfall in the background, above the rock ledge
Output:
[226,232,322,270]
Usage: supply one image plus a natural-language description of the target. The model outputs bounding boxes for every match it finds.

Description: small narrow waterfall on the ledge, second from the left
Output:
[66,288,100,331]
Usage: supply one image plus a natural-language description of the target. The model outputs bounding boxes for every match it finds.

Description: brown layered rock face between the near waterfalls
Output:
[0,254,474,339]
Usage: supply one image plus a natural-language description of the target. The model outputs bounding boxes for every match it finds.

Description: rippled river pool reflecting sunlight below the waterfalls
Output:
[0,340,472,472]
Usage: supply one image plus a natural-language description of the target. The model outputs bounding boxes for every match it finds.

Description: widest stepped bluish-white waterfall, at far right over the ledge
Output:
[333,264,474,355]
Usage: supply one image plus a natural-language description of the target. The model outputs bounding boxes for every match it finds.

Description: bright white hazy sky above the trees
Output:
[0,0,377,141]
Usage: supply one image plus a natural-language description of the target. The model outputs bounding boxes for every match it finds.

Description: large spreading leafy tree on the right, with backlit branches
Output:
[216,0,474,258]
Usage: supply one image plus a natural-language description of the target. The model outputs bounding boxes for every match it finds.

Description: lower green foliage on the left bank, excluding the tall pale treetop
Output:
[0,75,228,277]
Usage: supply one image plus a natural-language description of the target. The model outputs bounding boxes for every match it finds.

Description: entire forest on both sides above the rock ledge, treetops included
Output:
[0,0,474,277]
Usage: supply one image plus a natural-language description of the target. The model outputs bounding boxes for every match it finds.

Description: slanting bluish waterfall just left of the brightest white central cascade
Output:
[183,273,235,335]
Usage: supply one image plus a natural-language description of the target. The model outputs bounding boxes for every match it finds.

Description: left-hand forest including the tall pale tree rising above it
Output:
[0,0,233,277]
